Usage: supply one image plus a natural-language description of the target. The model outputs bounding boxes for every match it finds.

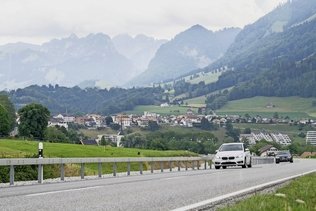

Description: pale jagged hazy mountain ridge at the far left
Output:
[0,33,162,90]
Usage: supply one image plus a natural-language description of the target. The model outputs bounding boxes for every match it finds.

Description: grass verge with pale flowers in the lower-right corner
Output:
[220,173,316,211]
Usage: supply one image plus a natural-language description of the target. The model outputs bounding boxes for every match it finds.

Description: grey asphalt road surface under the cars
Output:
[0,159,316,210]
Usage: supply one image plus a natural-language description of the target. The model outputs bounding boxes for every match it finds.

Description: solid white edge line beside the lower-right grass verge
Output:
[171,169,316,211]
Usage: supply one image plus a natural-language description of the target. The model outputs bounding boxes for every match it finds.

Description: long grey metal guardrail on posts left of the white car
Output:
[0,156,213,185]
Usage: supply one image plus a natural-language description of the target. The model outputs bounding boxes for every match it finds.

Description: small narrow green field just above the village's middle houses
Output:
[124,106,197,115]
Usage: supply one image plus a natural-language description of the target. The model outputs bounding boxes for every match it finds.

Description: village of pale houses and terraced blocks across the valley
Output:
[48,105,316,147]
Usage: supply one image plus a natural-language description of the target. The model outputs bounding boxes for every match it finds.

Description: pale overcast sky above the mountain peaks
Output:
[0,0,286,44]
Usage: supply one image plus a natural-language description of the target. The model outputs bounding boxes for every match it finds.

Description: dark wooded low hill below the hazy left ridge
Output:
[7,85,164,115]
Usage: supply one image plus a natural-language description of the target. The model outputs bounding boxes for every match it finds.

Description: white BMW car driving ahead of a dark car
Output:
[214,143,251,169]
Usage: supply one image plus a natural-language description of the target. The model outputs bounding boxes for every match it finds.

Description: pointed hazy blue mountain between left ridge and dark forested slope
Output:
[128,25,240,85]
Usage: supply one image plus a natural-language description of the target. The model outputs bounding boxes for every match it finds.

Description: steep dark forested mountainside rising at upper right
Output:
[203,0,316,100]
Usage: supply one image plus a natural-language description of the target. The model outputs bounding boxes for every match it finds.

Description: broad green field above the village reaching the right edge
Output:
[216,97,316,119]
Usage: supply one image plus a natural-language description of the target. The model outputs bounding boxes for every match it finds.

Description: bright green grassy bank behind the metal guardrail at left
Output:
[0,139,196,176]
